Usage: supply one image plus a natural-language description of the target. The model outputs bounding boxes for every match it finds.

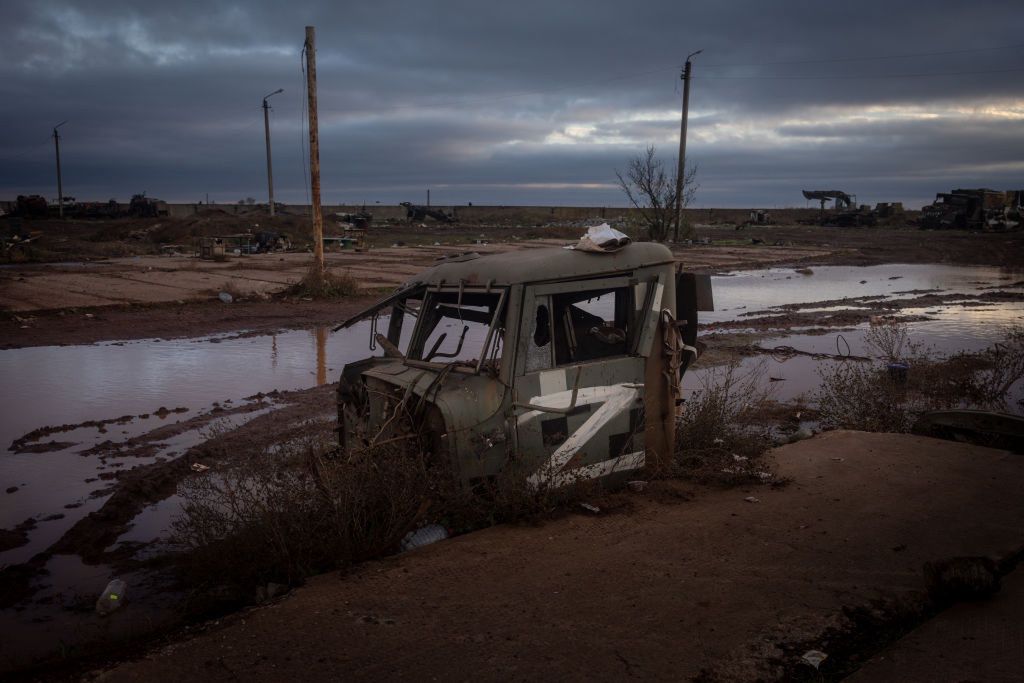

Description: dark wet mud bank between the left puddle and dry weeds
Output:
[0,385,334,672]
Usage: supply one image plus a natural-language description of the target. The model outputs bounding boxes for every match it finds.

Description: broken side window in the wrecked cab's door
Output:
[551,287,636,366]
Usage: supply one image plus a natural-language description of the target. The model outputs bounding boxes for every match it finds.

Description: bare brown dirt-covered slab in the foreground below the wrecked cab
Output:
[92,432,1024,681]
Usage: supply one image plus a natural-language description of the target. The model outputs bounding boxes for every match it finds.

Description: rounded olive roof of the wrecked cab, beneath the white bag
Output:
[401,242,674,289]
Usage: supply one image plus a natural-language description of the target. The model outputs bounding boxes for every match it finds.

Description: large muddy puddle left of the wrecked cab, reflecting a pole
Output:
[0,326,379,566]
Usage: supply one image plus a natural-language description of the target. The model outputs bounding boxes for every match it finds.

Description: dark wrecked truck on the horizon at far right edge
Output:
[918,187,1024,230]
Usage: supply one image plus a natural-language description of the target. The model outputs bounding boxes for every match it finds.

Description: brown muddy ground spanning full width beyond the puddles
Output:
[0,219,1024,348]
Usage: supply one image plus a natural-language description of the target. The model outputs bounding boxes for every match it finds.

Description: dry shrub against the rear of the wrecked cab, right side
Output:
[676,361,772,484]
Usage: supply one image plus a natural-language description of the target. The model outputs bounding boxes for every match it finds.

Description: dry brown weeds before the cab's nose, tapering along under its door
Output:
[173,432,595,600]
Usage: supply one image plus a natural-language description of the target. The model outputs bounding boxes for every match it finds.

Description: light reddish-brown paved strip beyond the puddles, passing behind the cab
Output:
[0,240,833,348]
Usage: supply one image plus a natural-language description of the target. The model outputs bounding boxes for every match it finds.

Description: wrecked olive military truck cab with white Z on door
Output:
[337,243,713,488]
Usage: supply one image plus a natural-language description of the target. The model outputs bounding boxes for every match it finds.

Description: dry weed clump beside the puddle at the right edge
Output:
[815,322,1024,432]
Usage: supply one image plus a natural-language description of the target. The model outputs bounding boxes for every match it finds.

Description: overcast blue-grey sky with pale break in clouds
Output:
[0,0,1024,207]
